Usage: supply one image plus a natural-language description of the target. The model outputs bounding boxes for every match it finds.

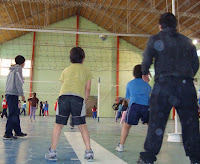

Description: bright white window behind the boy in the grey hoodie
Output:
[0,59,31,77]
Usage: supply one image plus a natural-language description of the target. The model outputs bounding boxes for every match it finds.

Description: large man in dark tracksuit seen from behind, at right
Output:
[137,13,200,164]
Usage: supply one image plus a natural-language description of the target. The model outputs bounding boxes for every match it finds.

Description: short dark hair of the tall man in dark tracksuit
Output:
[159,12,177,29]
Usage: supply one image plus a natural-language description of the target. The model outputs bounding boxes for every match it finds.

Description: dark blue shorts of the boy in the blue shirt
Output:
[125,103,149,125]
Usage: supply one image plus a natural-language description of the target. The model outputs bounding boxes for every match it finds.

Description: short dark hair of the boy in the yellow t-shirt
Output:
[70,47,85,63]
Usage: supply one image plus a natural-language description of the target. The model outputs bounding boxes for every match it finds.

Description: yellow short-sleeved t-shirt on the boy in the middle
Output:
[59,63,93,98]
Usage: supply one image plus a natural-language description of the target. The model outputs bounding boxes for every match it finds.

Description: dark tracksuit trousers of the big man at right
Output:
[140,77,200,162]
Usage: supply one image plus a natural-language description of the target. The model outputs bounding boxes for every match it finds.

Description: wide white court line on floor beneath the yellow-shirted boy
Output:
[64,132,127,164]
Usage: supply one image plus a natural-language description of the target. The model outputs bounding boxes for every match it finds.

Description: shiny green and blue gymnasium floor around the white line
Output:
[0,116,197,164]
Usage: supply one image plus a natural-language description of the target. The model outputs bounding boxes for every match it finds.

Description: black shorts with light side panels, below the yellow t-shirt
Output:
[56,95,86,125]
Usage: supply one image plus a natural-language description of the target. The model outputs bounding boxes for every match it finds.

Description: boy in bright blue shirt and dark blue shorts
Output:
[116,65,151,152]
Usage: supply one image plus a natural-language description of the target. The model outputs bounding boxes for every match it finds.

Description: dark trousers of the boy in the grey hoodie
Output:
[5,95,21,136]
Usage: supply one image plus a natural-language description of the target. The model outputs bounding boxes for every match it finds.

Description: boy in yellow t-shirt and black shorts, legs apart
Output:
[45,47,94,161]
